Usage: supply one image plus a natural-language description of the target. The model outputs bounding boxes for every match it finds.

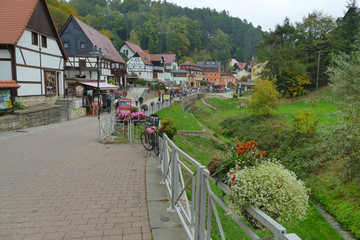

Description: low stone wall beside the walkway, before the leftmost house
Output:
[0,104,60,131]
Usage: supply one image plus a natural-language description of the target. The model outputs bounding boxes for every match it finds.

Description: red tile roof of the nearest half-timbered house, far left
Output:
[0,0,39,44]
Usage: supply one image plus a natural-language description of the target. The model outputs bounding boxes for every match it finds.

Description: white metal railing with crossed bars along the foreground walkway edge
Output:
[159,134,300,240]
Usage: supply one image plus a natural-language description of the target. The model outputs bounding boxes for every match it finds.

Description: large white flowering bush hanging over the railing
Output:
[227,160,309,224]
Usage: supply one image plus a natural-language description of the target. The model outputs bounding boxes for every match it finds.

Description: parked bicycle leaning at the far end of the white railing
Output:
[140,114,161,156]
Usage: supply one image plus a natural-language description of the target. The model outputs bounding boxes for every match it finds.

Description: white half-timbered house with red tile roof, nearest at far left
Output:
[0,0,67,106]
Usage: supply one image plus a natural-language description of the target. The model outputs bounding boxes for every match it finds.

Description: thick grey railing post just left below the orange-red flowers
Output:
[194,166,206,240]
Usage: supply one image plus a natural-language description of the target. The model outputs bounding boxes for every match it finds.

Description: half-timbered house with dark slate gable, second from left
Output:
[60,16,126,94]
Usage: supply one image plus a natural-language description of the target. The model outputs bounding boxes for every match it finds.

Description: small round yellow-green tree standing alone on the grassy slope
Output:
[248,80,280,116]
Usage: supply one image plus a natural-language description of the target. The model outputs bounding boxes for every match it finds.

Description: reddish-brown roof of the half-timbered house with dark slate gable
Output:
[64,15,125,63]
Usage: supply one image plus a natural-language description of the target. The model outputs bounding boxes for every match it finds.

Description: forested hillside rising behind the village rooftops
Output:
[47,0,263,67]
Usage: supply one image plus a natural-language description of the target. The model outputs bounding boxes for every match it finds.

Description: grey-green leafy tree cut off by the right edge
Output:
[328,42,360,180]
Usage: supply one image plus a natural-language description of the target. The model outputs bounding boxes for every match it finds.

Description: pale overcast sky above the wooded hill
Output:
[166,0,348,31]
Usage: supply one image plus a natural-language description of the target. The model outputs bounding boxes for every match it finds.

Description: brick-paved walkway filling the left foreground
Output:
[0,117,152,240]
